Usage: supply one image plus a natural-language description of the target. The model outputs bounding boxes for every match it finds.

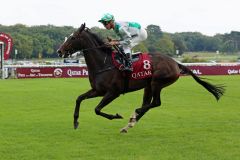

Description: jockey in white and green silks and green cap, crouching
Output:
[98,13,147,71]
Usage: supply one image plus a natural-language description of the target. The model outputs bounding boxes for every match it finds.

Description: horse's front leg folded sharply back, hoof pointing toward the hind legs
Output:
[95,92,123,120]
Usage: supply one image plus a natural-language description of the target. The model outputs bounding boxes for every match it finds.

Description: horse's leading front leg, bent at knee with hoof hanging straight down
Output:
[73,89,99,129]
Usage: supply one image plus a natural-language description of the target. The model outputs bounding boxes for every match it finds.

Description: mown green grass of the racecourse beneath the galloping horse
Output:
[0,76,240,160]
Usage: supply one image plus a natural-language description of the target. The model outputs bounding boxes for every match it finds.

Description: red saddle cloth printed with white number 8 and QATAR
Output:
[112,52,152,80]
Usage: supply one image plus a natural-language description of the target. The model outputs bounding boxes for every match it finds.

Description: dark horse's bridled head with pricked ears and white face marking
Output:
[57,23,85,58]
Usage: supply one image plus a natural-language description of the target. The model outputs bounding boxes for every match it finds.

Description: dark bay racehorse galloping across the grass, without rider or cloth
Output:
[57,24,224,132]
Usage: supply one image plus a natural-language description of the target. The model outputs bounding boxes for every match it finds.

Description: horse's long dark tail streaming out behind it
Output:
[178,63,225,100]
